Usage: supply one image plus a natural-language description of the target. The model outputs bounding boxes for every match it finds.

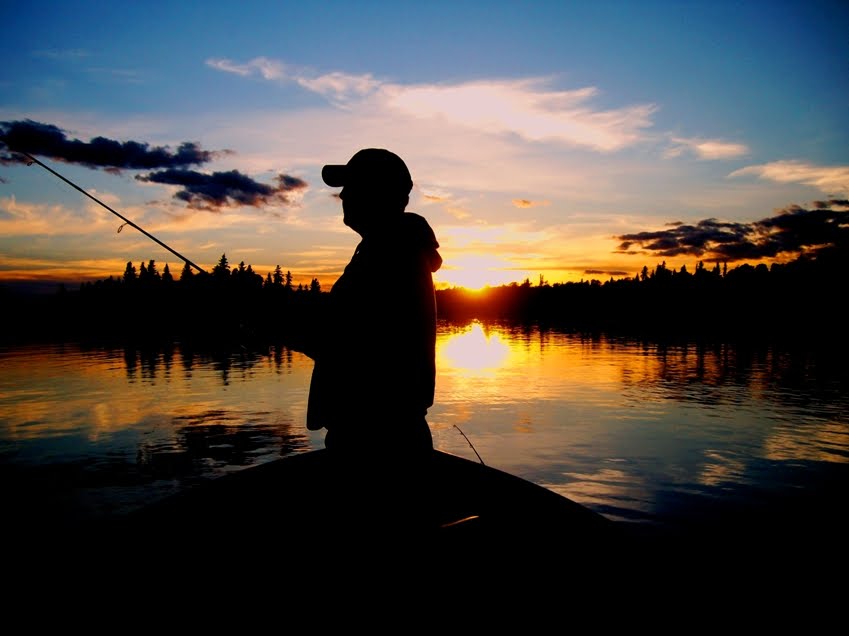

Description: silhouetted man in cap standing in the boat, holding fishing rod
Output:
[307,148,442,458]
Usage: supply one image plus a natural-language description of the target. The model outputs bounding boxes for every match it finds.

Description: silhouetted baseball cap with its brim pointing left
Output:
[321,148,413,194]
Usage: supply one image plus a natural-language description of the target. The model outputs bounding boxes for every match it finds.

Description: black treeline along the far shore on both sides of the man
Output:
[3,247,849,347]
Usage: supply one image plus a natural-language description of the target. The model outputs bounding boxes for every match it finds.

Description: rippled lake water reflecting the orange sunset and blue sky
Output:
[0,322,849,531]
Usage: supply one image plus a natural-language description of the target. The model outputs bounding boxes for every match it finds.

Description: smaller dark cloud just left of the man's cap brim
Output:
[136,169,307,211]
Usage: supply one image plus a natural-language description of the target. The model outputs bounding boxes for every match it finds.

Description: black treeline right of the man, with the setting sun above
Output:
[438,246,849,343]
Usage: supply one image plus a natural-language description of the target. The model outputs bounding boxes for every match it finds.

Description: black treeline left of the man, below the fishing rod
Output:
[3,253,327,346]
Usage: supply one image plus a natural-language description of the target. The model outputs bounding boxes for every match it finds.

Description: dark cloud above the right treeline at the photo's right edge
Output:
[617,199,849,262]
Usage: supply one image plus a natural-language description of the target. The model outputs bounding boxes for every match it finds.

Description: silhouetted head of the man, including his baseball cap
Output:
[321,148,413,234]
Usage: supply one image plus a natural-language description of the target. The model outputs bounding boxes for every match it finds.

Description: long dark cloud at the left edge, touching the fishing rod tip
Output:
[0,119,220,170]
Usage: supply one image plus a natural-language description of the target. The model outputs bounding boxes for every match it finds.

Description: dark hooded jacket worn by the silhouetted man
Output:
[307,212,442,435]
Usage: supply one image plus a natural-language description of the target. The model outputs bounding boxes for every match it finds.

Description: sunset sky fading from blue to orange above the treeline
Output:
[0,0,849,289]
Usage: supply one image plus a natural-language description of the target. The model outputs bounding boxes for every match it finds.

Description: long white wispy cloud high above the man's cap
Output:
[206,57,656,152]
